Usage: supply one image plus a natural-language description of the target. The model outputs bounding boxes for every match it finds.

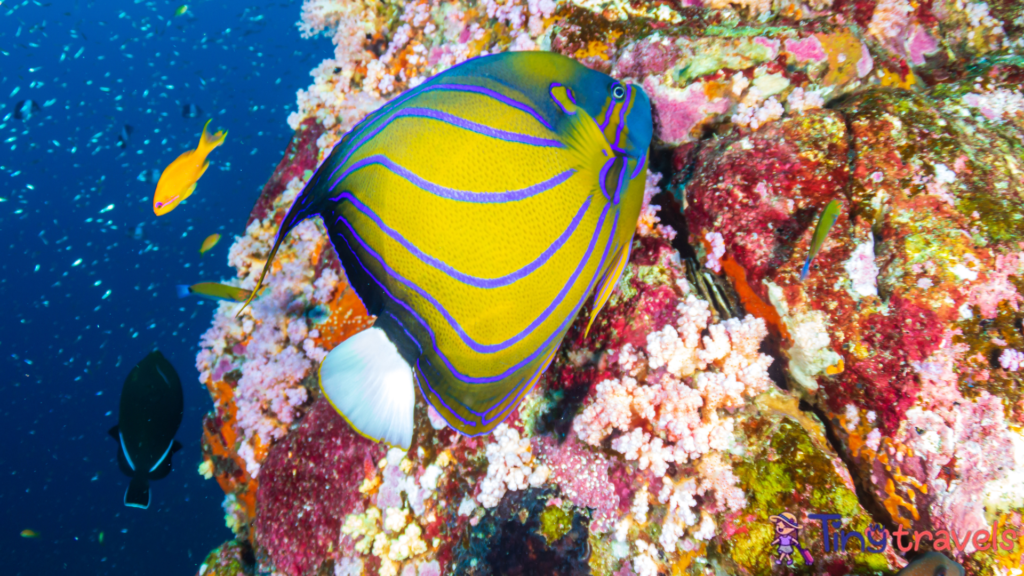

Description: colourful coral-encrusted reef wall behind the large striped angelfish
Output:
[197,0,1024,576]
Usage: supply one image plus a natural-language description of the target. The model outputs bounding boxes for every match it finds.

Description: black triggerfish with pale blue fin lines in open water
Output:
[110,351,184,509]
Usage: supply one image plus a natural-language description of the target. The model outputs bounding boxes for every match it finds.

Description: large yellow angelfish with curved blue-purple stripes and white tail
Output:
[243,52,652,449]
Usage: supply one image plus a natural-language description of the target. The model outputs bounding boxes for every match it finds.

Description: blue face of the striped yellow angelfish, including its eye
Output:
[573,71,654,158]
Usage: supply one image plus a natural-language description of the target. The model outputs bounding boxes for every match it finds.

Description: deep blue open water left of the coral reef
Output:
[0,0,333,576]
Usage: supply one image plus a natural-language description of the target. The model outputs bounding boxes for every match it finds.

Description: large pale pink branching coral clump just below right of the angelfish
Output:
[573,294,771,476]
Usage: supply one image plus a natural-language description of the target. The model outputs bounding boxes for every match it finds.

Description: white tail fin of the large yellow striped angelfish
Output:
[319,328,416,450]
